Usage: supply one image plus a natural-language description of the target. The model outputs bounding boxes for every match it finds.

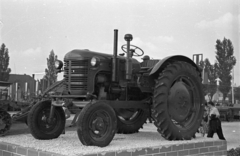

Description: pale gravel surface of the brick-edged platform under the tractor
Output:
[0,125,216,156]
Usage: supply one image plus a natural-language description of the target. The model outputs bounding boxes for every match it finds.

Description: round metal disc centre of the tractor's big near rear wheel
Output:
[168,82,192,122]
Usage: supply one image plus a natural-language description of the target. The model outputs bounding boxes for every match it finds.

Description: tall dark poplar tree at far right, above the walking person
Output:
[214,37,236,100]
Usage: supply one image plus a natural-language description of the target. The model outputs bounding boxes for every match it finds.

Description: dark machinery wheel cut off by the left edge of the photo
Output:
[0,109,12,136]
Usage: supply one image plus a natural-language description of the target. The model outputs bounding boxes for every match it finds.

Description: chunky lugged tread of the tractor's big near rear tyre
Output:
[152,62,202,140]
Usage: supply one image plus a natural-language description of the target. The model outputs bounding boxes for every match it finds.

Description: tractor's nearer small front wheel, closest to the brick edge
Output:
[77,102,117,147]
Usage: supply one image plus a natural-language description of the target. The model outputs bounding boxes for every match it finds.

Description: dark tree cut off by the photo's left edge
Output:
[0,43,11,81]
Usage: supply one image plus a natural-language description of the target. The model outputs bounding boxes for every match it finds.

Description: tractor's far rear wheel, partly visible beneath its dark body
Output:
[116,109,149,134]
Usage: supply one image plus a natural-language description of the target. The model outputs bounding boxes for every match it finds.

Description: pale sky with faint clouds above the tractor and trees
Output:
[0,0,240,86]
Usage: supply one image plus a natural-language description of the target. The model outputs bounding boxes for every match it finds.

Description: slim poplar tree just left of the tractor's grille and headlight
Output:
[44,50,57,87]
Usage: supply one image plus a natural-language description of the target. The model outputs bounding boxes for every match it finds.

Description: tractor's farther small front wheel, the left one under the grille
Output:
[28,100,66,140]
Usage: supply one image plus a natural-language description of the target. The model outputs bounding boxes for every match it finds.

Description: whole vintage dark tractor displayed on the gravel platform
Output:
[28,30,204,147]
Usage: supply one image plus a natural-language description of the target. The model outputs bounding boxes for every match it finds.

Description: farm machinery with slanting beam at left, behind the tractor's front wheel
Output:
[0,81,64,136]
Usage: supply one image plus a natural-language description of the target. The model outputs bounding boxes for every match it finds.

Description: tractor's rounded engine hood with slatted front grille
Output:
[64,49,140,96]
